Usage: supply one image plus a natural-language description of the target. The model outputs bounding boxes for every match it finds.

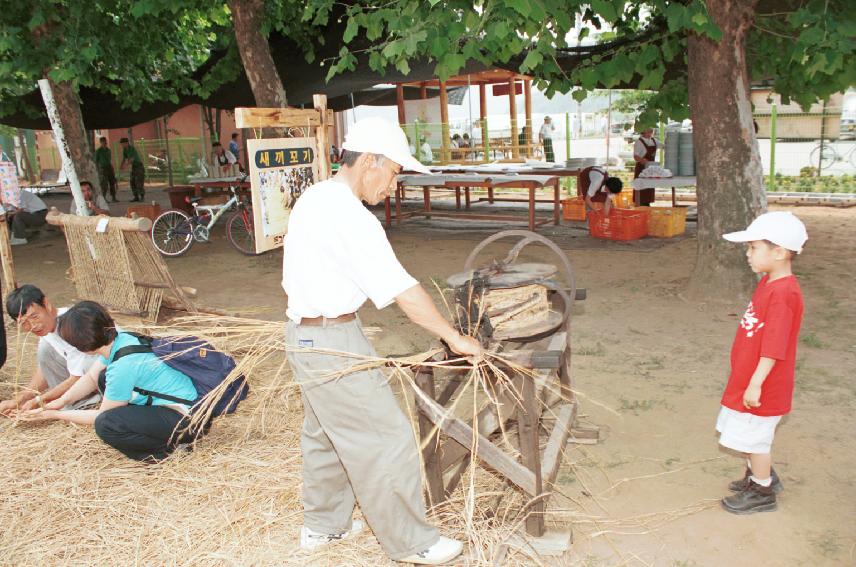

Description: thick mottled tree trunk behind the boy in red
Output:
[688,0,767,297]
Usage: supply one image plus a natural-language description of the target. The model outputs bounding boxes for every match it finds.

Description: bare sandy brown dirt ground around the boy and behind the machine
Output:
[0,186,856,566]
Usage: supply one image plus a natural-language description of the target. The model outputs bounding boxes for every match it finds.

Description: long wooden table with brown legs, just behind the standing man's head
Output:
[385,174,561,230]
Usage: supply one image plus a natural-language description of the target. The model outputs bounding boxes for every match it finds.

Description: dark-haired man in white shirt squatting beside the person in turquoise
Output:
[0,284,103,415]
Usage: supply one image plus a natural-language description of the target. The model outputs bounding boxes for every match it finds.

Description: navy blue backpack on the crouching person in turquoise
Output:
[98,333,250,417]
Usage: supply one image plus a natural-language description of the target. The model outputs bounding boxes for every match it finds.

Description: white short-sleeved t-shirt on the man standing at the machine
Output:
[282,180,418,322]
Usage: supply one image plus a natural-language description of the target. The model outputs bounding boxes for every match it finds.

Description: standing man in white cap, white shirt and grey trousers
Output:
[282,118,482,565]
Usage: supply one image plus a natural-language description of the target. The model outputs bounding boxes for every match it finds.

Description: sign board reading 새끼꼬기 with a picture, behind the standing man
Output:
[247,138,320,253]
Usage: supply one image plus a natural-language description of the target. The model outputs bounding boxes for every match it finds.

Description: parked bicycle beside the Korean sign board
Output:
[152,182,256,258]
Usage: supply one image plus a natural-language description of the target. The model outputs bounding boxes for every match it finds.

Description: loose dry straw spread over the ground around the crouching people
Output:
[0,316,707,567]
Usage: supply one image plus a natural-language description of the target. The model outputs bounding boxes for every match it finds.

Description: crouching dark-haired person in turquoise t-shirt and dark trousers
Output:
[25,301,204,462]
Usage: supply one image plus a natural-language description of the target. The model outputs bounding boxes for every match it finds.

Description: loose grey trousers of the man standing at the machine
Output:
[285,319,440,560]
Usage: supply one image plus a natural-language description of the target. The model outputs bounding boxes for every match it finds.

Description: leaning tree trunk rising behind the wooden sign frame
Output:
[229,0,288,108]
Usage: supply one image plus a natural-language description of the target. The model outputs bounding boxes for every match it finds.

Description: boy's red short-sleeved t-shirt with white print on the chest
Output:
[722,275,803,416]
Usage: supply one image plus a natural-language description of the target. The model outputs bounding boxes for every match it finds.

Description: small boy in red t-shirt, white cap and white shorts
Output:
[716,212,808,514]
